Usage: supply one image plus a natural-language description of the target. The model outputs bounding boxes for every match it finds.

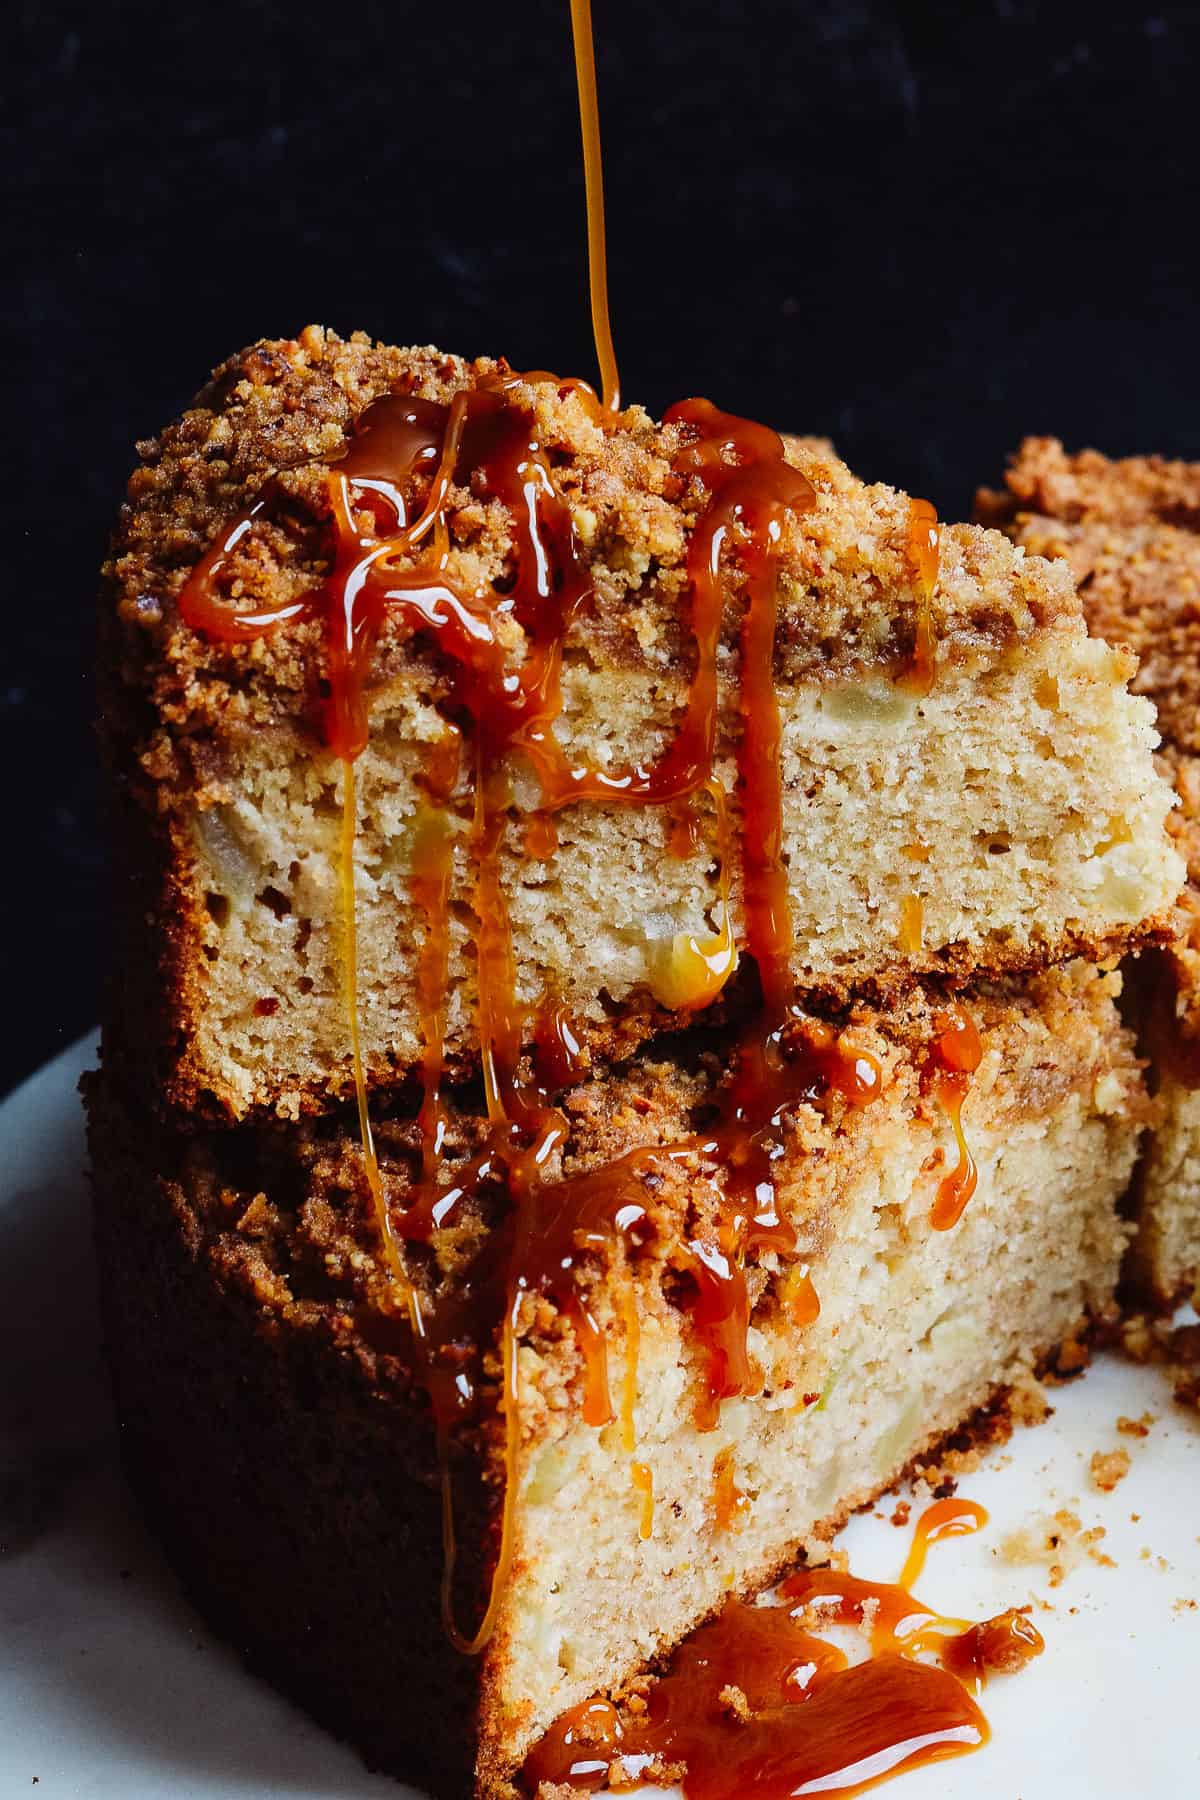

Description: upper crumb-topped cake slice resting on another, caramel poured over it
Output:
[101,329,1182,1120]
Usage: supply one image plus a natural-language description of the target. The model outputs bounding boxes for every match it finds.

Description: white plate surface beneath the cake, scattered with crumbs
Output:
[0,1039,1200,1800]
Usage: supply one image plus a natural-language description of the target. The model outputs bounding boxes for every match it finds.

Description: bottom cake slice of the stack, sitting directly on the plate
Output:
[88,965,1148,1800]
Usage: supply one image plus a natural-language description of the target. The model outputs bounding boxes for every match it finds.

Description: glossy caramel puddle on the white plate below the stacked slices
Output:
[524,1501,1043,1800]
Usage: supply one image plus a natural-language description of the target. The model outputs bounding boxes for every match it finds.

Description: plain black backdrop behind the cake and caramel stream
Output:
[0,0,1200,1089]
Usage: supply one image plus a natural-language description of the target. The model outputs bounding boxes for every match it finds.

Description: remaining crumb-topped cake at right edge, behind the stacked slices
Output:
[977,437,1200,1307]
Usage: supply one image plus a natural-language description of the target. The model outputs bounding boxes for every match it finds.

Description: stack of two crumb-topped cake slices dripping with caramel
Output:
[90,329,1182,1796]
